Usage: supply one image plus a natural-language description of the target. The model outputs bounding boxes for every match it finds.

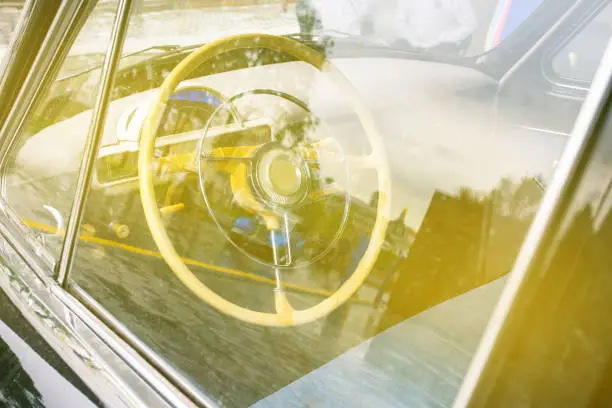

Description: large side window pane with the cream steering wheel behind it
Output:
[7,0,608,407]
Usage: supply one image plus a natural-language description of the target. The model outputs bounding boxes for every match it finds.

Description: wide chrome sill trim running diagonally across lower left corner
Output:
[0,197,193,408]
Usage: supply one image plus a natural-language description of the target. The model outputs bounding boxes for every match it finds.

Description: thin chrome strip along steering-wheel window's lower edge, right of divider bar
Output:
[70,282,218,408]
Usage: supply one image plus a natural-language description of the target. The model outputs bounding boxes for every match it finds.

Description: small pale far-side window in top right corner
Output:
[552,4,612,83]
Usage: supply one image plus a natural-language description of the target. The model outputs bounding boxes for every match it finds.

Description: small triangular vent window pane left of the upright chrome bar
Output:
[3,1,117,256]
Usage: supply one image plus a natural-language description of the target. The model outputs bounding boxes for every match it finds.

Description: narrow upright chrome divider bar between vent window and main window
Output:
[56,0,133,287]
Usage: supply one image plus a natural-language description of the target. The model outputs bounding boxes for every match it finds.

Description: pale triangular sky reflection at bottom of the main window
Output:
[253,279,506,408]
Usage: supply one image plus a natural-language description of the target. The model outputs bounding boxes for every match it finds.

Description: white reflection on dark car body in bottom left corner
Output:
[0,321,95,408]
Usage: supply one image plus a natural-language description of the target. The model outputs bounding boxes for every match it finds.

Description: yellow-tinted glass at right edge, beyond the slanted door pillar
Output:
[469,89,612,408]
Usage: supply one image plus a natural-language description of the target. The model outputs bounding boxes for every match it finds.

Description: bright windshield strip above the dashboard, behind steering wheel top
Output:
[68,0,544,66]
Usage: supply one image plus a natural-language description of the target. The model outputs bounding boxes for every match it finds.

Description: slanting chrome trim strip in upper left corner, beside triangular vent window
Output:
[0,0,97,171]
